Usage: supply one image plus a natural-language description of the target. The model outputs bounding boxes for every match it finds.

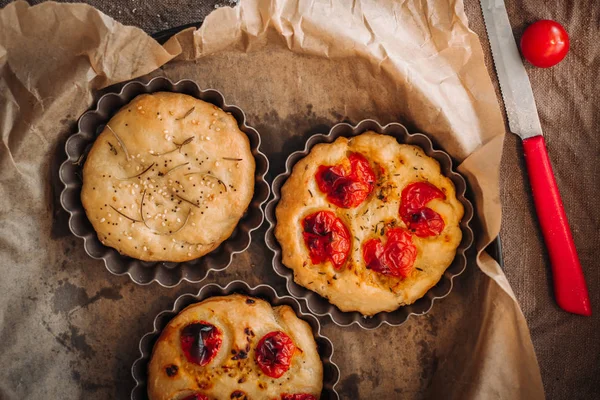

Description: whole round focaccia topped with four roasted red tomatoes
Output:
[275,132,464,315]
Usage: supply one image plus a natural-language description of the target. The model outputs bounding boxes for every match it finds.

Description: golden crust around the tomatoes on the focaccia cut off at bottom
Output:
[148,294,323,400]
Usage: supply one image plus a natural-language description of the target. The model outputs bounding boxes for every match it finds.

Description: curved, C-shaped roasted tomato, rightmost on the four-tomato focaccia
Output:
[400,182,446,237]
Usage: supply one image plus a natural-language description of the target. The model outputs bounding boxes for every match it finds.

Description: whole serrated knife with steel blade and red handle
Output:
[480,0,592,316]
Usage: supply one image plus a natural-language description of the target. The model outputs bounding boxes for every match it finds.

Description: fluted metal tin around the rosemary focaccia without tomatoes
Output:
[59,77,270,287]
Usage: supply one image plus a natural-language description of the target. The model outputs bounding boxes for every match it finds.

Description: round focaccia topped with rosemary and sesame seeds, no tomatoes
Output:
[81,92,255,262]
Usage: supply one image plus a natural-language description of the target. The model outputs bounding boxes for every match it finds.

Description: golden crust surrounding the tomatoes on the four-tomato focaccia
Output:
[275,132,464,315]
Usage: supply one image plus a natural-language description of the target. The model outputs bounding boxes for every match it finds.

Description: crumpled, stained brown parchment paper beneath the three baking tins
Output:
[0,0,544,399]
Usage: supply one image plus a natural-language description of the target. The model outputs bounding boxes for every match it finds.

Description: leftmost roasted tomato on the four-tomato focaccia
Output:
[302,211,350,269]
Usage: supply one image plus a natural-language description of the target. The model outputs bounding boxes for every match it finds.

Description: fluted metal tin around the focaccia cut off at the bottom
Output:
[131,281,340,400]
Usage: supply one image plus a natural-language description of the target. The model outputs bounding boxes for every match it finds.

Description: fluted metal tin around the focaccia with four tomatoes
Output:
[265,119,473,329]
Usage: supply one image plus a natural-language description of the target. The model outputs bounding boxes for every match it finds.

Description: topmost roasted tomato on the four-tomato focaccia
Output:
[316,153,375,208]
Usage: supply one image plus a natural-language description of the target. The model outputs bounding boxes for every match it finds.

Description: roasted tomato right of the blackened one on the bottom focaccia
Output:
[256,331,296,378]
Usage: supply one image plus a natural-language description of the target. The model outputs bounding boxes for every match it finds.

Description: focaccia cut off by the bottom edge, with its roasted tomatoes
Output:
[148,294,323,400]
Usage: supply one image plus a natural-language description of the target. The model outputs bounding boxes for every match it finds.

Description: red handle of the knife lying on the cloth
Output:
[523,135,592,316]
